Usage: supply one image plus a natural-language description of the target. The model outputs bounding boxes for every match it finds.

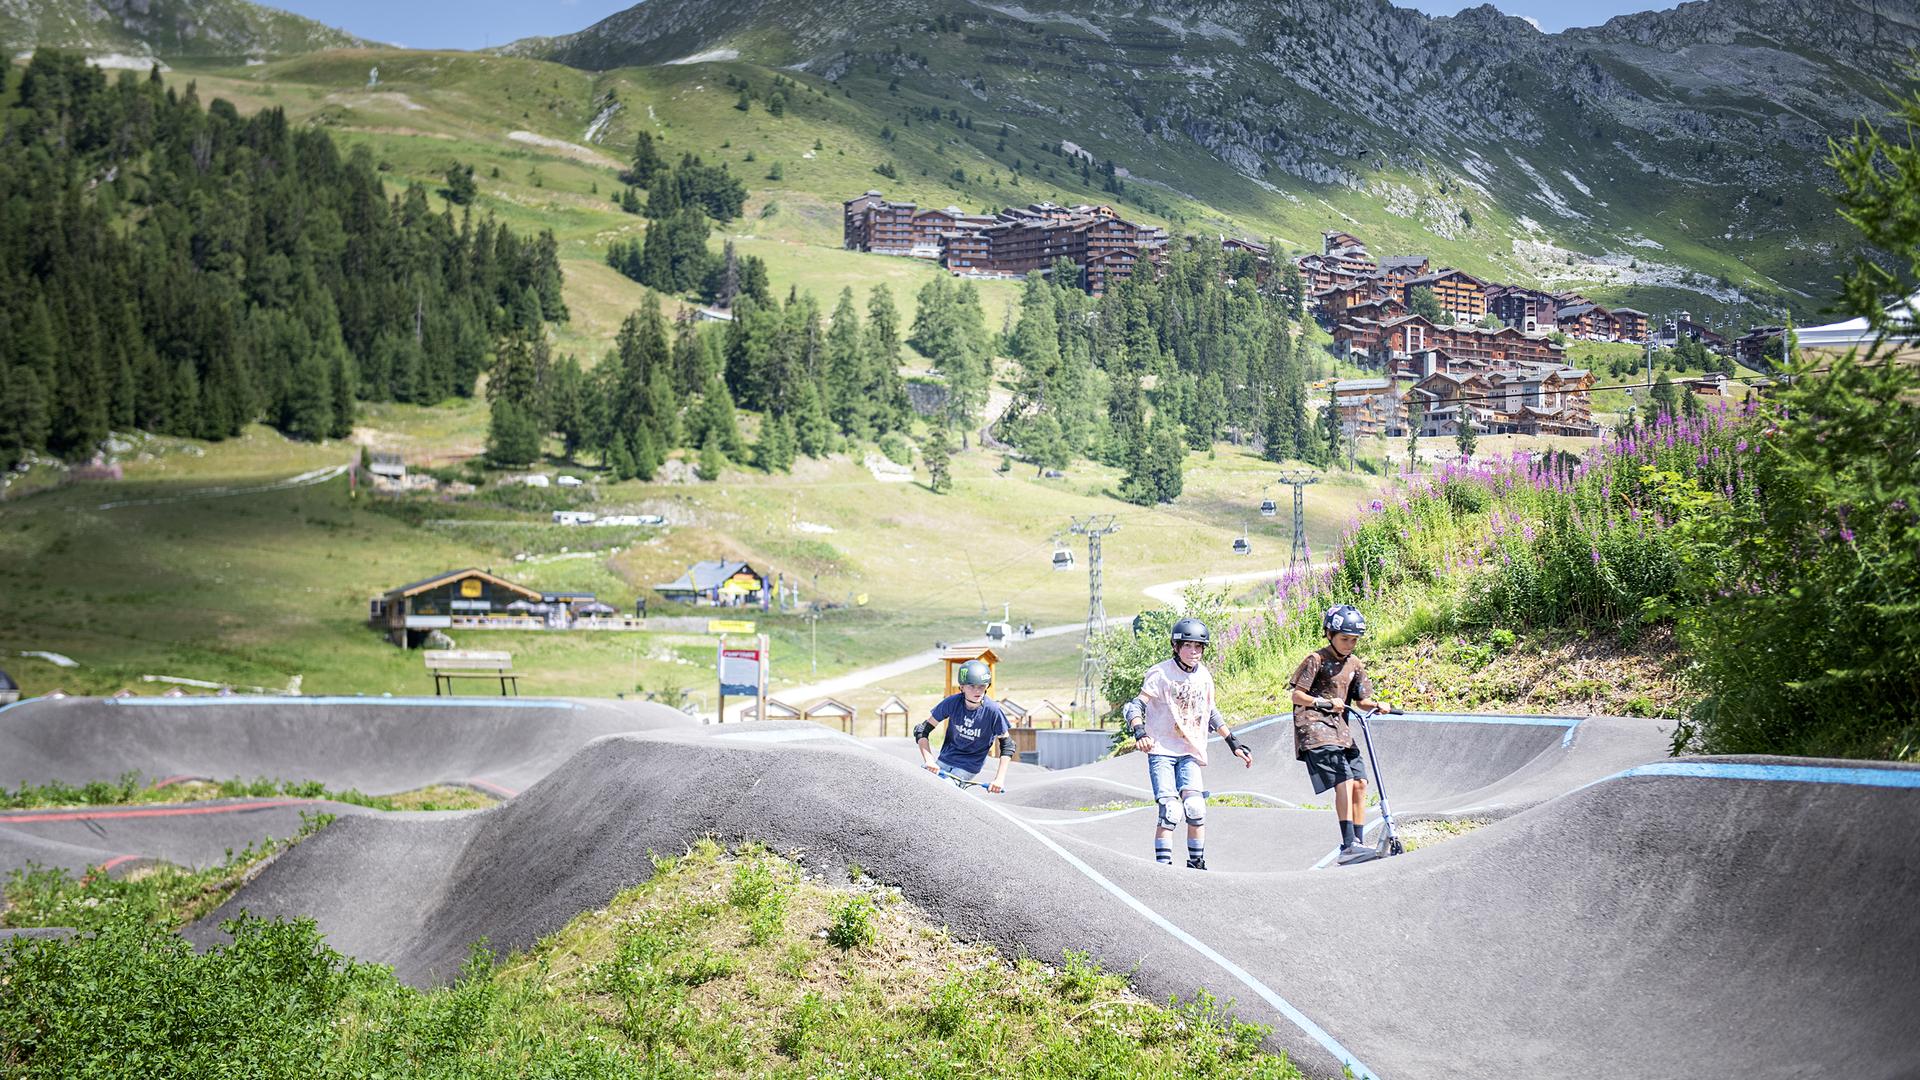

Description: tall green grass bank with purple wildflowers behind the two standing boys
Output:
[1104,397,1768,730]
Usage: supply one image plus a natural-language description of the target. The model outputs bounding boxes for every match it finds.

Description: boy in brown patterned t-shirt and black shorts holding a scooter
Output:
[1288,603,1380,859]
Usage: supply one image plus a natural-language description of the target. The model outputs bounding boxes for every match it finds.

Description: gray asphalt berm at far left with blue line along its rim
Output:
[0,696,693,876]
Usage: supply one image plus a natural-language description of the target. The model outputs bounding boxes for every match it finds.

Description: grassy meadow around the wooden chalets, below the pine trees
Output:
[0,386,1371,705]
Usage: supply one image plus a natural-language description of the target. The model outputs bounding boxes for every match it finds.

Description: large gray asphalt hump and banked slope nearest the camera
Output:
[196,728,1920,1078]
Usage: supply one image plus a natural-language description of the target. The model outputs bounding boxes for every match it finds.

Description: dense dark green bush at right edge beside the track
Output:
[1668,357,1920,761]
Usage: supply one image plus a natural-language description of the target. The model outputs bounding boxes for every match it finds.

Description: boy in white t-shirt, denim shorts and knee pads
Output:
[1121,619,1254,871]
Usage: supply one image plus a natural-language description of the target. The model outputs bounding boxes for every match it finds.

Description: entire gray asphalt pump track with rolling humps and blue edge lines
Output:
[0,698,1920,1080]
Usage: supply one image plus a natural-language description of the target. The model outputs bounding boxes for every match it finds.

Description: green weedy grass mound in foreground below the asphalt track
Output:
[0,844,1300,1080]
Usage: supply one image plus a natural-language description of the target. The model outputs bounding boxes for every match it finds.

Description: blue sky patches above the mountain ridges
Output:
[263,0,1672,48]
